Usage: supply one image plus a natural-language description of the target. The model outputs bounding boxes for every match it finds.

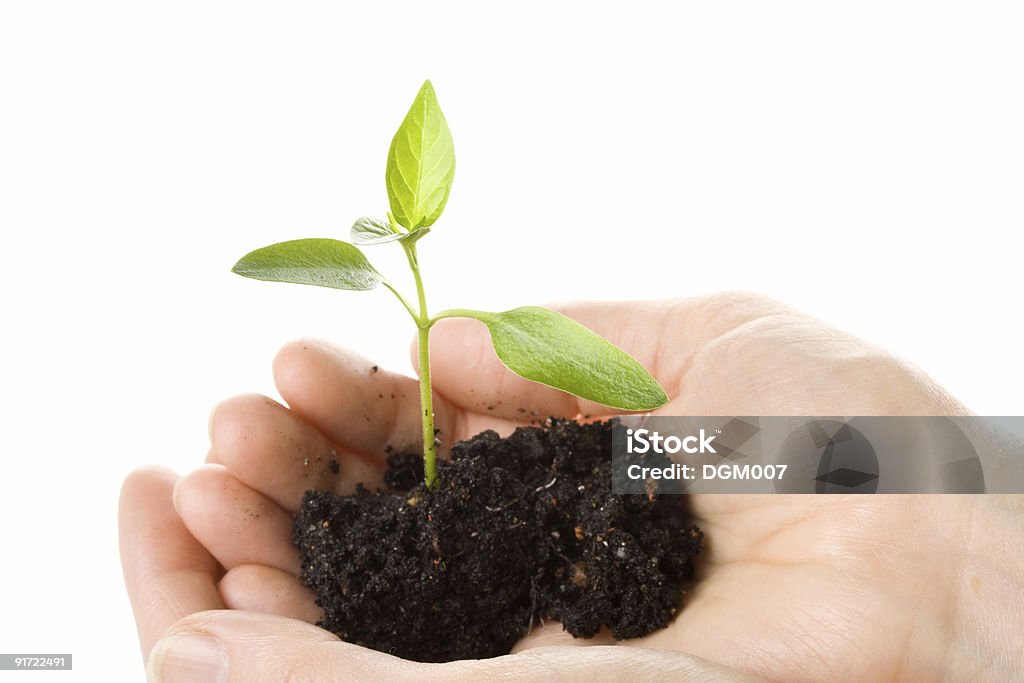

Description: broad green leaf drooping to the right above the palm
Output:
[471,306,669,411]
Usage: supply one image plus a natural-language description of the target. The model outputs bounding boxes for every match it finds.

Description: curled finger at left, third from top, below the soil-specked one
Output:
[174,465,299,575]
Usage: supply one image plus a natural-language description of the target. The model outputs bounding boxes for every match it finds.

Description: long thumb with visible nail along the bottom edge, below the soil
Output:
[146,610,759,683]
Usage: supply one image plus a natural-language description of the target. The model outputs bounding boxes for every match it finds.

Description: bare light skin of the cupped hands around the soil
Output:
[120,294,1024,681]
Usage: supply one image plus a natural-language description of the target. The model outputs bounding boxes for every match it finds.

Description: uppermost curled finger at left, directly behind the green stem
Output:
[273,340,453,454]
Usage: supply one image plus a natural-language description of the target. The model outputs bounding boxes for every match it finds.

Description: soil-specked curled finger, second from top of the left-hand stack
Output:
[207,394,383,512]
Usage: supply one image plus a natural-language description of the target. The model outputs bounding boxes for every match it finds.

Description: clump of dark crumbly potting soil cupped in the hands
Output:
[294,420,703,661]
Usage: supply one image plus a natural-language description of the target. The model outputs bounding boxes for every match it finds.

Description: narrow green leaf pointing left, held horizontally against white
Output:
[231,238,384,290]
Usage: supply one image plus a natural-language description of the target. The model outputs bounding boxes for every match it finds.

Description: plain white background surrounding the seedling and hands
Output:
[0,0,1024,680]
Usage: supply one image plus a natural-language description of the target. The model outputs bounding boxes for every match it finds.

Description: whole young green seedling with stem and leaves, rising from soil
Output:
[231,81,668,487]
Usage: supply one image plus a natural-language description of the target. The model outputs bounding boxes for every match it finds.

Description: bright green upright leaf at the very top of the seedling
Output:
[384,81,455,230]
